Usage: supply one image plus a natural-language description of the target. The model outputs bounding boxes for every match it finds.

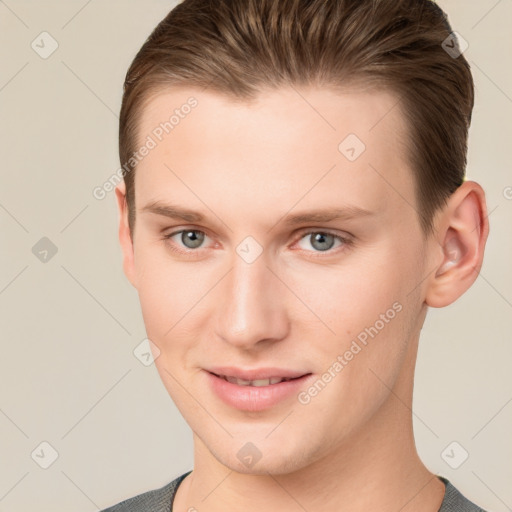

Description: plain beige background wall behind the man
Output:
[0,0,512,512]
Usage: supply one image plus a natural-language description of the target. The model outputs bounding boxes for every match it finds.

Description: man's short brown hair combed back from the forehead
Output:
[119,0,474,237]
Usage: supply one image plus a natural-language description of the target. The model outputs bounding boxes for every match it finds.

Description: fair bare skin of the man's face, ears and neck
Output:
[116,87,488,512]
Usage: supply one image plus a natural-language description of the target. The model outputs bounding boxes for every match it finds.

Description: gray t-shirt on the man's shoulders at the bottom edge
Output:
[101,471,485,512]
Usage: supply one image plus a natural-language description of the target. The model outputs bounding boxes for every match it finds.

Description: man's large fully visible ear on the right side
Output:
[425,181,489,308]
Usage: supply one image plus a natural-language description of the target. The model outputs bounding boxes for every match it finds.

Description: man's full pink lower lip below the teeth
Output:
[206,372,312,412]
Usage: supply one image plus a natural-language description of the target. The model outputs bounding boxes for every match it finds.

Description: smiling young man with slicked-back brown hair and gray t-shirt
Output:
[103,0,488,512]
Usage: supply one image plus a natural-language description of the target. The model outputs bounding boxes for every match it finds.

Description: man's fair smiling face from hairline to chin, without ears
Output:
[119,88,428,474]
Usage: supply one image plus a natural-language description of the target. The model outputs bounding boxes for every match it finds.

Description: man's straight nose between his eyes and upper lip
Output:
[216,254,289,350]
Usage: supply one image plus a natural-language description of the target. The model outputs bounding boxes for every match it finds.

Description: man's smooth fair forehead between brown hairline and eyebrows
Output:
[135,87,414,227]
